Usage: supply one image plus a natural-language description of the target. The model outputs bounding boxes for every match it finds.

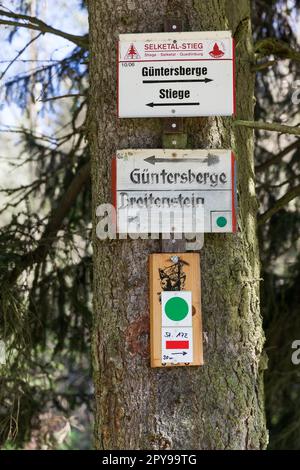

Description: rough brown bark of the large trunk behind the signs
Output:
[88,0,267,449]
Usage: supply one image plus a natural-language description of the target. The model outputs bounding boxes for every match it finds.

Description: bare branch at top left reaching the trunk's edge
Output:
[0,9,88,49]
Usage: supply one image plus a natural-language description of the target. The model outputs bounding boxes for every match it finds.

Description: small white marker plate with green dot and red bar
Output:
[161,291,193,364]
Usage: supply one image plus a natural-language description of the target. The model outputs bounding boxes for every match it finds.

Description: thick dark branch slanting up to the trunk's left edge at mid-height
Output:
[8,162,90,284]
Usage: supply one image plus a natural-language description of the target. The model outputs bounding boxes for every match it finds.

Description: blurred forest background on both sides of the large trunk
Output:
[0,0,300,449]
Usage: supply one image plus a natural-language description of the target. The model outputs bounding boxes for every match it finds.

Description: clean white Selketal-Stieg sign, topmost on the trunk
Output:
[118,31,235,118]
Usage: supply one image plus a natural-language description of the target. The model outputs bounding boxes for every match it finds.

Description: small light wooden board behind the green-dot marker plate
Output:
[149,253,203,367]
